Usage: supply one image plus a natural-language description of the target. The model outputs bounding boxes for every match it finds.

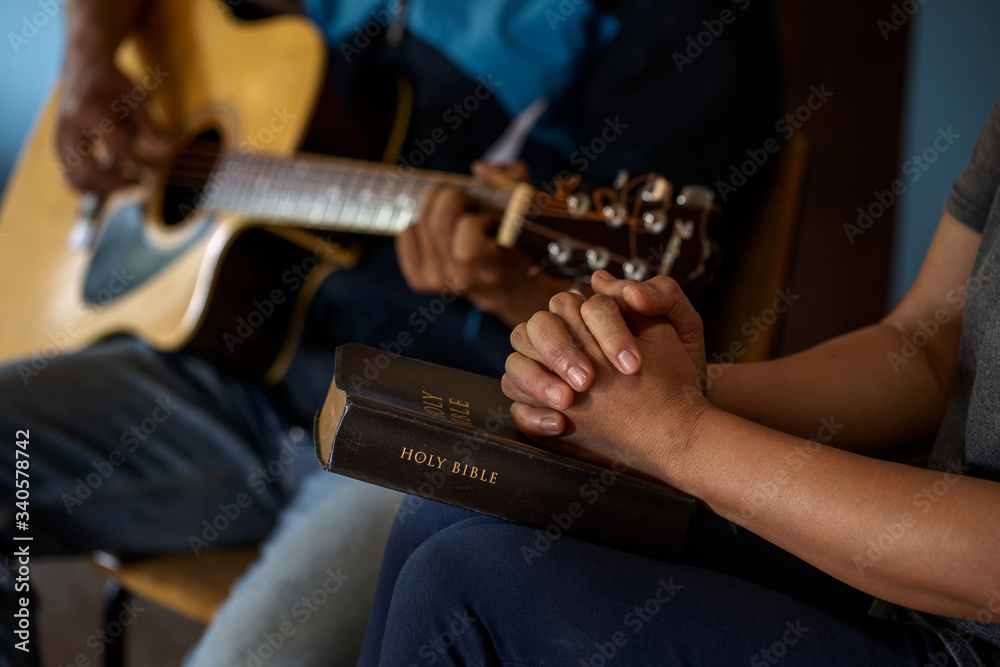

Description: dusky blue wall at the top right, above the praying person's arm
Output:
[890,0,1000,303]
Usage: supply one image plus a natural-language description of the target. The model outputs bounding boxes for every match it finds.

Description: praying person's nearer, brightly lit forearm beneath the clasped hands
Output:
[657,408,1000,617]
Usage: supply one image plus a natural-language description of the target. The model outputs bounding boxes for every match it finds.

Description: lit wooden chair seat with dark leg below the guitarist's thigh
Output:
[93,546,258,667]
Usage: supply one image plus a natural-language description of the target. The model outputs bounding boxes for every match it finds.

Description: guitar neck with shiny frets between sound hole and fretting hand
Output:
[201,152,513,236]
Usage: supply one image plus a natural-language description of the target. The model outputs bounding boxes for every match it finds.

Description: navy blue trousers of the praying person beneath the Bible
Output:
[359,501,954,667]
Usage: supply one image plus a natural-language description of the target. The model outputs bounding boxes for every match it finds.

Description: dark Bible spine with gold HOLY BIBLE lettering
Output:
[325,399,695,559]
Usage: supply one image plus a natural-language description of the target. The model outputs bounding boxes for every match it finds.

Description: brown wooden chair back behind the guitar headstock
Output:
[706,132,809,363]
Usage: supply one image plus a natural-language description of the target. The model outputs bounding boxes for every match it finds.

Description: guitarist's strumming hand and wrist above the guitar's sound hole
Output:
[55,0,170,194]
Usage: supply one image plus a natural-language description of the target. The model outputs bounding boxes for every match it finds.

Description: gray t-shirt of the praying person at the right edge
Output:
[884,99,1000,667]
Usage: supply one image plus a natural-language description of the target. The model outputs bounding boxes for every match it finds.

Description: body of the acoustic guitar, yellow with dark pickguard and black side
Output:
[0,0,353,382]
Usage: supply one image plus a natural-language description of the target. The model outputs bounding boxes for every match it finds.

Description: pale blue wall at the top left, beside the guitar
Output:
[0,0,65,186]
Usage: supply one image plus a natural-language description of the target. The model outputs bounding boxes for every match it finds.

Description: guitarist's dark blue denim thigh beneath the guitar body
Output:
[0,337,287,663]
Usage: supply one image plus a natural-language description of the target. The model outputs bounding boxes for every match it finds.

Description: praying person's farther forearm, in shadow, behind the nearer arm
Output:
[708,322,957,454]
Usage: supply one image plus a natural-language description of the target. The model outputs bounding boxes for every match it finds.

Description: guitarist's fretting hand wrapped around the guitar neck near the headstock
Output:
[396,162,571,326]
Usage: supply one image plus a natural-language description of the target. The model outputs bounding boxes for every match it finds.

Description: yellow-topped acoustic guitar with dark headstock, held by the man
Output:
[0,0,721,384]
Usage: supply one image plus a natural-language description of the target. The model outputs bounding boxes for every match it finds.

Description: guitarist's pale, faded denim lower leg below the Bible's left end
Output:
[187,465,403,667]
